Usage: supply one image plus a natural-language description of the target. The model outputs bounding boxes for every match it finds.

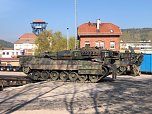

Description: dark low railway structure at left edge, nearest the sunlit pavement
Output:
[0,75,31,91]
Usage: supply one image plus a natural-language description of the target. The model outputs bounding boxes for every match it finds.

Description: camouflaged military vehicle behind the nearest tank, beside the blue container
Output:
[115,46,143,76]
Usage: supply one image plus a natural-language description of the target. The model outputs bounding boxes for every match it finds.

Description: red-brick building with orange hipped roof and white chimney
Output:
[78,19,122,50]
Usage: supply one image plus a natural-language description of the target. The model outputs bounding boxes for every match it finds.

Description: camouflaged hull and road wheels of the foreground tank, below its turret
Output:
[21,57,105,82]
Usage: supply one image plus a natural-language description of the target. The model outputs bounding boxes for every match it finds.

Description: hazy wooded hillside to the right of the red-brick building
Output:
[121,28,152,41]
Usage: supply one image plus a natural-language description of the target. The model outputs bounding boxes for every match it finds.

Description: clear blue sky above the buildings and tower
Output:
[0,0,152,42]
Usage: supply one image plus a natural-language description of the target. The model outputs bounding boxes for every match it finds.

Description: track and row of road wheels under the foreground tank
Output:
[27,70,108,83]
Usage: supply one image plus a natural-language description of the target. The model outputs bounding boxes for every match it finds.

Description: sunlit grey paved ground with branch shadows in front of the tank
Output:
[0,71,152,114]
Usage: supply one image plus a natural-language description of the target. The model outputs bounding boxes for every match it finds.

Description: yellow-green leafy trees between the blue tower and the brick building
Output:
[35,31,75,55]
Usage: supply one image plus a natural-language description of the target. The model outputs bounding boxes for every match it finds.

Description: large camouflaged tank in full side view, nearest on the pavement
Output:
[19,49,116,82]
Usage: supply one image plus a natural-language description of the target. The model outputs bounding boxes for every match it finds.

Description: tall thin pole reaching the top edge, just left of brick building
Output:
[74,0,77,49]
